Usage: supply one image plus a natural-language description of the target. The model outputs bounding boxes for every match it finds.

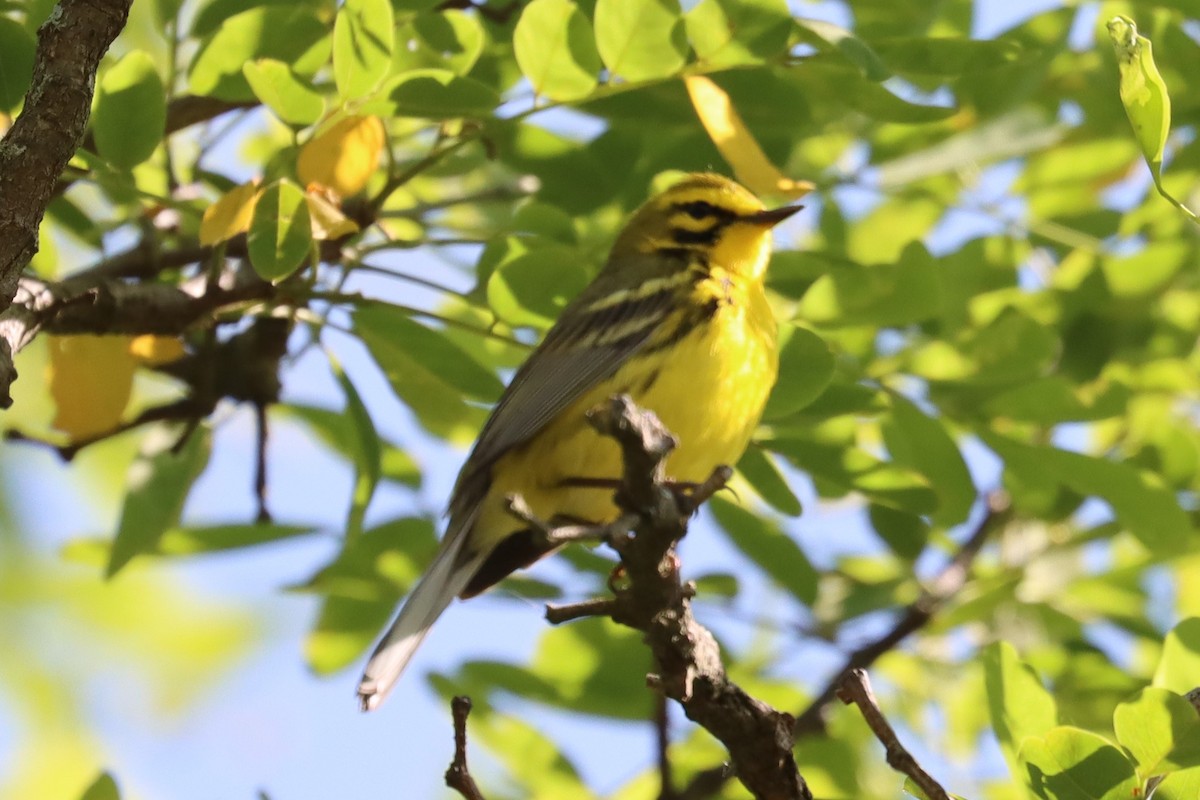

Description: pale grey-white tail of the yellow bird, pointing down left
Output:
[359,536,486,711]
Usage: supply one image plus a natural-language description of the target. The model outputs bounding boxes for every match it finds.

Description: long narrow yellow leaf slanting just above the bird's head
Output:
[684,76,815,198]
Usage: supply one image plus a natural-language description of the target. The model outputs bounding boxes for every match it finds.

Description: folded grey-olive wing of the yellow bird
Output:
[449,267,676,533]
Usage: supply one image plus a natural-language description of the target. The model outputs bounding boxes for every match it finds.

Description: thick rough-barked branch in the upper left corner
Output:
[0,0,133,408]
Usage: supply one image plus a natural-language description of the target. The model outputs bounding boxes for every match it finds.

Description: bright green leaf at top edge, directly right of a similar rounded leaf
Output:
[594,0,688,83]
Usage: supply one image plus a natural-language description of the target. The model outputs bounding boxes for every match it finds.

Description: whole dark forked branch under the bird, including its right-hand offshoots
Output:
[494,397,984,800]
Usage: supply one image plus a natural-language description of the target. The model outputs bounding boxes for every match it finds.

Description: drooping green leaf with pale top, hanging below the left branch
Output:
[104,426,212,578]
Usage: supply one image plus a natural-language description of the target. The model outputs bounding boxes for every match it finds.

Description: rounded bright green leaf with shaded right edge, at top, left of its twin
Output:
[512,0,601,101]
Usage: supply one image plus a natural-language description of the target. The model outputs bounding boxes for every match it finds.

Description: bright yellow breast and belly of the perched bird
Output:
[476,299,778,541]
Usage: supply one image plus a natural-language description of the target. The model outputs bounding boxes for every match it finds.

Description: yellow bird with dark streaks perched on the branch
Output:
[358,173,802,711]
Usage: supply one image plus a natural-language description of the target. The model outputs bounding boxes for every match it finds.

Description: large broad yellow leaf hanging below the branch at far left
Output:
[47,336,134,439]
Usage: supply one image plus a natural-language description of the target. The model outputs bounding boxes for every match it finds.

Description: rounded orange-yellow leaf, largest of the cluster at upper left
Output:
[296,116,386,197]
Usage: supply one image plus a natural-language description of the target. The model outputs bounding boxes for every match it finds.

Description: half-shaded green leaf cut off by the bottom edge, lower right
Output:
[1020,726,1140,800]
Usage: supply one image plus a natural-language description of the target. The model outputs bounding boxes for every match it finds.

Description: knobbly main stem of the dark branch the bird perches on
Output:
[547,397,812,800]
